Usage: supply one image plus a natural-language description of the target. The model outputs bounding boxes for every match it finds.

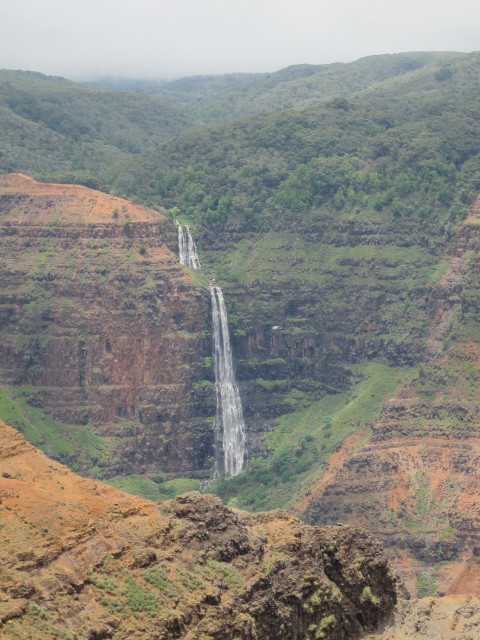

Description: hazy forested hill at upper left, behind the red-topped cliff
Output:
[0,71,193,186]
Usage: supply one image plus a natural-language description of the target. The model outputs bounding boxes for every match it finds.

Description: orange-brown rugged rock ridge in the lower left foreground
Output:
[0,423,397,640]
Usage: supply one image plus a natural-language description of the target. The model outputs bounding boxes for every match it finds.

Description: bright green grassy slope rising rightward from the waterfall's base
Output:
[214,363,412,511]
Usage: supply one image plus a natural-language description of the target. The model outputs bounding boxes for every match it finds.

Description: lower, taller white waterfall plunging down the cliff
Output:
[210,287,245,476]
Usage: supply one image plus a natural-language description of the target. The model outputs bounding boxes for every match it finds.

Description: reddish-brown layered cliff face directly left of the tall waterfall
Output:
[0,174,214,474]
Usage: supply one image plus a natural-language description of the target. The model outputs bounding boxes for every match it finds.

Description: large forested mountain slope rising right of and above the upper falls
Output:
[126,48,480,222]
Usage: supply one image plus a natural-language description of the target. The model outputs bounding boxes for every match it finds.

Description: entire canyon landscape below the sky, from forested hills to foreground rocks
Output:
[0,53,480,640]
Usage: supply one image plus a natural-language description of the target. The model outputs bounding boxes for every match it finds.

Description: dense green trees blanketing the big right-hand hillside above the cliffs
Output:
[128,54,479,230]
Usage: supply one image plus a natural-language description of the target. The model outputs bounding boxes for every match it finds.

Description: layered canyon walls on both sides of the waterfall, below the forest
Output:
[0,170,480,595]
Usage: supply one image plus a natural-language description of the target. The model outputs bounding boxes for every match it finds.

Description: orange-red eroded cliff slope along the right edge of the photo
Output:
[298,198,480,595]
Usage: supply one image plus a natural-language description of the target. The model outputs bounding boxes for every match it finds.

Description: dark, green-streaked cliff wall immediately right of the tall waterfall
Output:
[198,218,450,438]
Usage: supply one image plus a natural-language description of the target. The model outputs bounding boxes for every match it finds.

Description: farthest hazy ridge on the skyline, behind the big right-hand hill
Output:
[84,52,466,123]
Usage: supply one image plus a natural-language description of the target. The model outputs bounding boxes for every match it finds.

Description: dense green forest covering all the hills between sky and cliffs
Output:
[0,54,478,228]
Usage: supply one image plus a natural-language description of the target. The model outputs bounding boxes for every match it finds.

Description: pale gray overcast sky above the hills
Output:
[0,0,480,78]
